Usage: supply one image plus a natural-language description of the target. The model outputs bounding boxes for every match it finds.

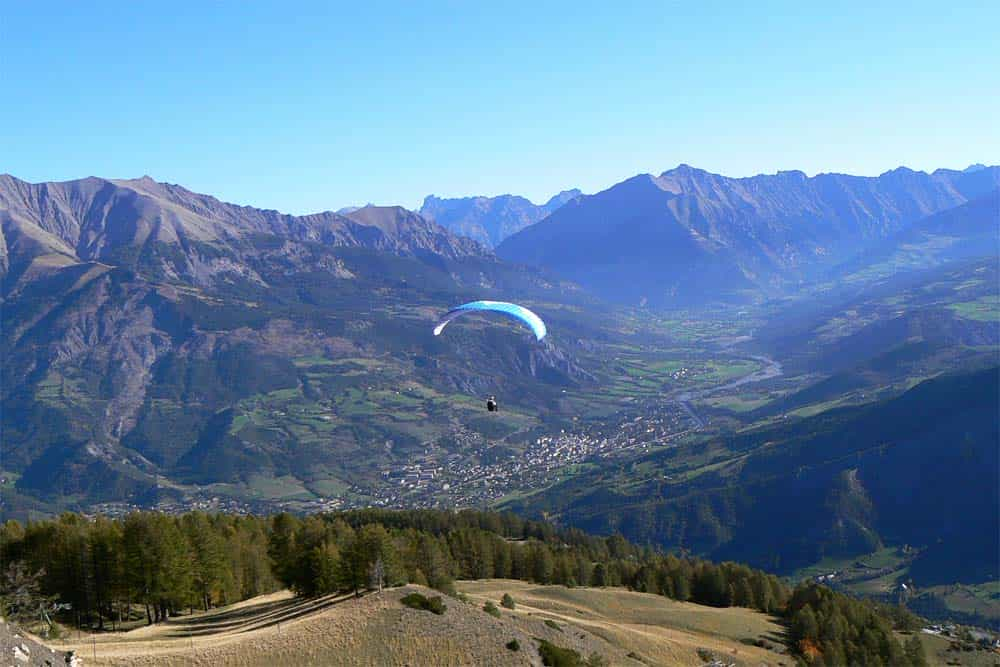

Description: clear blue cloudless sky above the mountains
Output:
[0,0,1000,213]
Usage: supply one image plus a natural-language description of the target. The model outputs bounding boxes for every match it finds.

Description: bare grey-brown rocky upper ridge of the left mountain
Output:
[0,175,489,286]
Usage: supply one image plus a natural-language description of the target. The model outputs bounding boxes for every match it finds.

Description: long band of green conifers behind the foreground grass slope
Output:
[0,509,922,665]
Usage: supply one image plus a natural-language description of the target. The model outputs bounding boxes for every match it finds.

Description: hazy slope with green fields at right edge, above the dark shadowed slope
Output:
[754,258,1000,384]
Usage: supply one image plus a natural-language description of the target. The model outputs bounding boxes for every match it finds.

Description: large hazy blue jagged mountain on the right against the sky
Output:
[497,165,1000,303]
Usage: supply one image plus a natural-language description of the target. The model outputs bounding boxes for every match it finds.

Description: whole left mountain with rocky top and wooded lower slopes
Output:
[0,176,589,504]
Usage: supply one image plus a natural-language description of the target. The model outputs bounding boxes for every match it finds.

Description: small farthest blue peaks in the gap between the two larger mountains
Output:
[420,189,581,248]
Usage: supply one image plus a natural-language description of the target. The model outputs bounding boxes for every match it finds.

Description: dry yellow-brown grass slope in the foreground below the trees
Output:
[52,580,792,667]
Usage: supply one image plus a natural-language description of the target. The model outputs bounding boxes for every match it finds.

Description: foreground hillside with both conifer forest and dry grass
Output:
[0,510,921,667]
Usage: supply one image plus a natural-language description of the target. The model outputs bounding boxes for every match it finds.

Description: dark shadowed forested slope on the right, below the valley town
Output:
[512,367,1000,584]
